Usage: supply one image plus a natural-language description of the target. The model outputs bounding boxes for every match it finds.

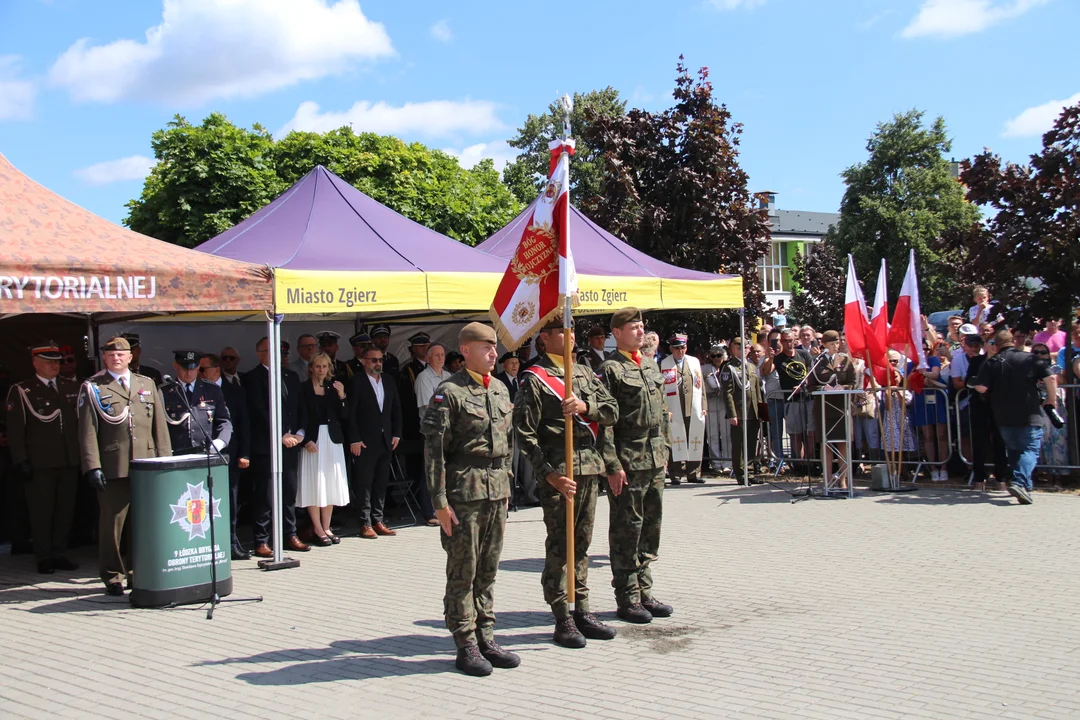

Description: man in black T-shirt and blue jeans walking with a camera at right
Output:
[974,330,1061,505]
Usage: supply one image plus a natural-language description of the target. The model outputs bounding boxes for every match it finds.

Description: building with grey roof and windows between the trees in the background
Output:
[757,192,840,310]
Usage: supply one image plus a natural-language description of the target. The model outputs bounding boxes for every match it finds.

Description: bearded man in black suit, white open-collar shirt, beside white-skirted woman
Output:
[346,348,402,540]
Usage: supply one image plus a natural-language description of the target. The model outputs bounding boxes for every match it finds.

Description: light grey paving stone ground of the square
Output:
[0,481,1080,720]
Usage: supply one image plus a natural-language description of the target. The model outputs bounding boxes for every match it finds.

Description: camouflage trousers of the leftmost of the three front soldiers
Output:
[438,500,507,648]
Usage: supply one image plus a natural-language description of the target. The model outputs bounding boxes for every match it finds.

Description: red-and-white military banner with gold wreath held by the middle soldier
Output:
[489,138,578,350]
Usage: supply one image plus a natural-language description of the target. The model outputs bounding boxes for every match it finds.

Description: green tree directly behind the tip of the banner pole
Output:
[502,86,626,205]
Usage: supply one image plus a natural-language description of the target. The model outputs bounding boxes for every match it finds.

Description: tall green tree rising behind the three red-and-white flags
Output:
[825,110,981,313]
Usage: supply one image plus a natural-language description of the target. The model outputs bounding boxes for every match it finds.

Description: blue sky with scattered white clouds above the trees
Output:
[0,0,1080,222]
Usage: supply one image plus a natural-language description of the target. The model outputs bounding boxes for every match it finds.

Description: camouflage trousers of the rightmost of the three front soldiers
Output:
[608,467,664,608]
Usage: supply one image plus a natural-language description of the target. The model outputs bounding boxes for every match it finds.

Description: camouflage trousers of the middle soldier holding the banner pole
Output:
[537,475,599,620]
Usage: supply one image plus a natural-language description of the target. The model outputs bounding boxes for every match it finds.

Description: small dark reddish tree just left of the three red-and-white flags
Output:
[792,243,847,330]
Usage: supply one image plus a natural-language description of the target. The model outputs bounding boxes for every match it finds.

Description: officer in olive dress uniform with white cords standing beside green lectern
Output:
[79,337,173,596]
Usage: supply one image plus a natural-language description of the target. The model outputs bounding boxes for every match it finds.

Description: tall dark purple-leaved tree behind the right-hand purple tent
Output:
[584,57,769,338]
